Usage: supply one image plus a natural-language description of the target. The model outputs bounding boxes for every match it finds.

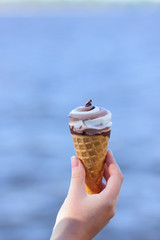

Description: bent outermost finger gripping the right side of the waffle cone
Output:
[102,150,123,201]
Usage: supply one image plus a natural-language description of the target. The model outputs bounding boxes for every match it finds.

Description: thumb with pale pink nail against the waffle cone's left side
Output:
[69,157,86,195]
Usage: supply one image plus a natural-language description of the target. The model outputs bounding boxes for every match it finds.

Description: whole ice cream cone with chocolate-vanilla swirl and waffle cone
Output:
[69,100,112,194]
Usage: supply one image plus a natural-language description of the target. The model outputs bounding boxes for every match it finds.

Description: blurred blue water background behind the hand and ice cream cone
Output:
[0,0,160,240]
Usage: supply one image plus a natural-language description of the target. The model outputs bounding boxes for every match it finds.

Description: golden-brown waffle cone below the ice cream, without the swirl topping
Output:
[72,134,109,194]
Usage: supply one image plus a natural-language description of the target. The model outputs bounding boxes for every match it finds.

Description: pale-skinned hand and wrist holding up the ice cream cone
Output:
[51,150,123,240]
